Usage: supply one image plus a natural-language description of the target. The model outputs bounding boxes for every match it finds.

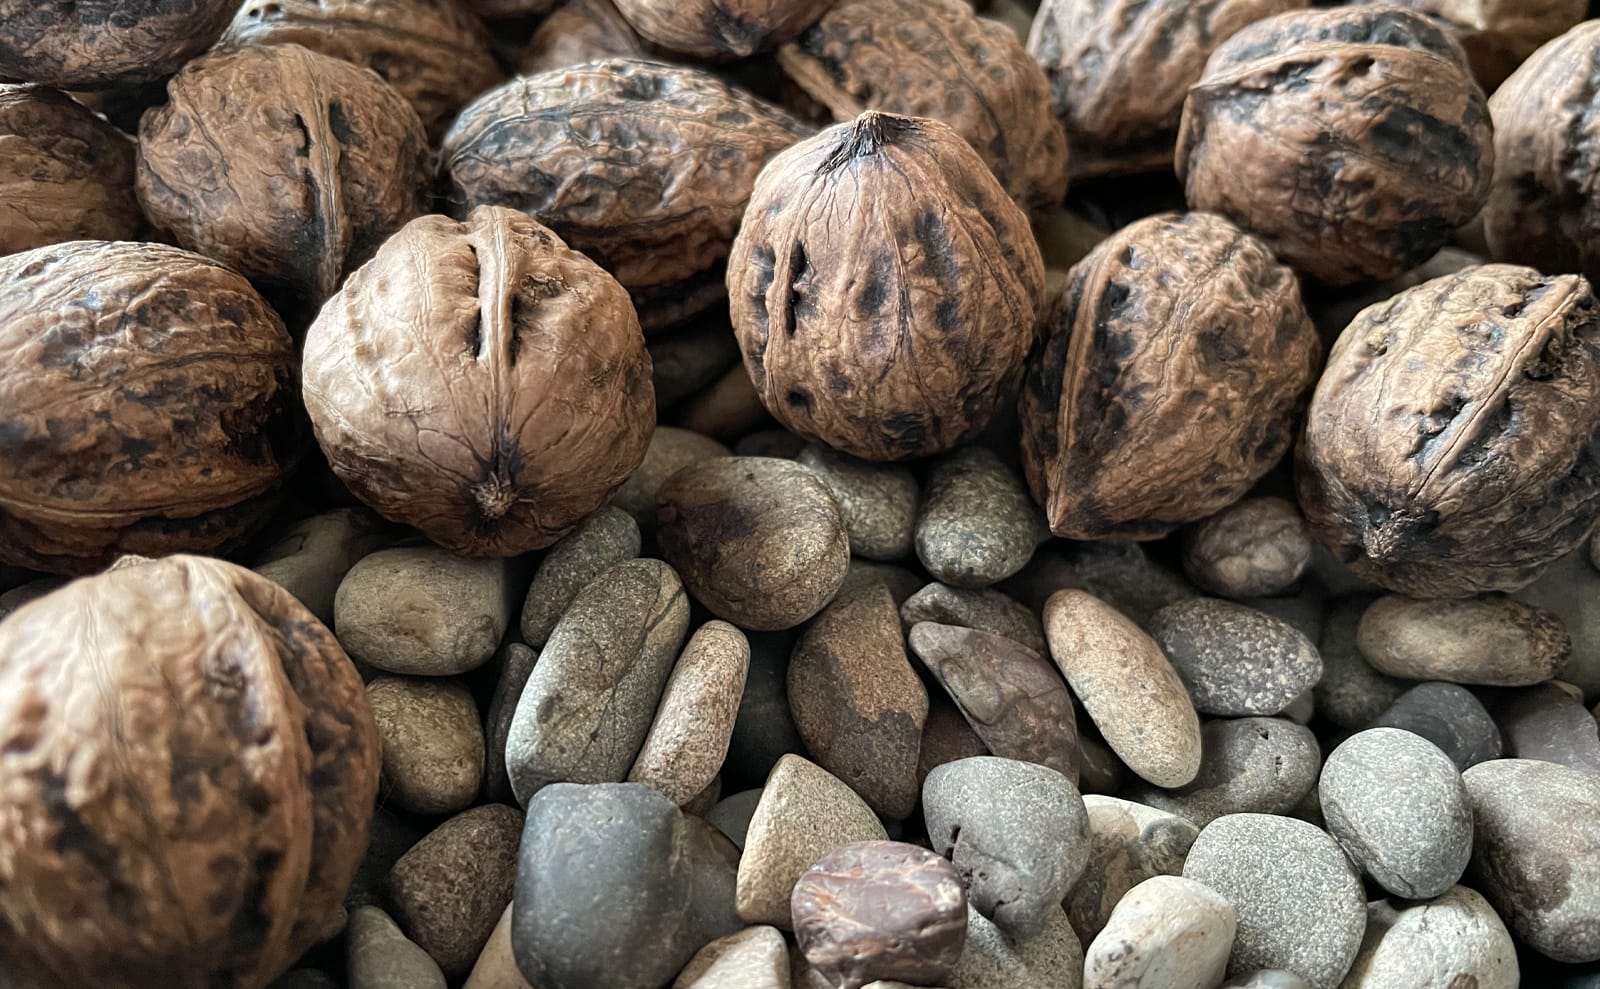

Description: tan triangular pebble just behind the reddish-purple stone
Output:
[738,755,888,930]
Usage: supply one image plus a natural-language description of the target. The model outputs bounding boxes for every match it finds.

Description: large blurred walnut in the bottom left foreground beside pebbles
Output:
[0,557,379,989]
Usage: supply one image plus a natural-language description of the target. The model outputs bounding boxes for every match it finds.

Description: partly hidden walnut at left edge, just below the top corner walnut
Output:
[0,85,144,254]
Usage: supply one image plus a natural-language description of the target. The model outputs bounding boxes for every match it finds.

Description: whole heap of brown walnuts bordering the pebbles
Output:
[0,0,1600,989]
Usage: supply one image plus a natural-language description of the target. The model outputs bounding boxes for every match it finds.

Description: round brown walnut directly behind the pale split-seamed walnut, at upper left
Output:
[138,45,429,312]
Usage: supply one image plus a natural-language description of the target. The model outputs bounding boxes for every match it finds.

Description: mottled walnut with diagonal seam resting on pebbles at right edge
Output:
[1296,264,1600,597]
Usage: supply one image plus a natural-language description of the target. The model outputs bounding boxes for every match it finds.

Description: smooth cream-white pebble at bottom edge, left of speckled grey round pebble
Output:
[1083,875,1237,989]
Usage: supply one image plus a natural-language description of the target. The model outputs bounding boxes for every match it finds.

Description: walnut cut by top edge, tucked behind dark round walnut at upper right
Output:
[1027,0,1309,178]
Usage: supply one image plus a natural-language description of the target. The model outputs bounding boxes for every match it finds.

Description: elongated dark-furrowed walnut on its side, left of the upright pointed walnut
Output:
[443,59,806,330]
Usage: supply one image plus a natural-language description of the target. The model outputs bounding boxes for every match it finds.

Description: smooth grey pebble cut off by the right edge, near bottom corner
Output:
[1461,759,1600,962]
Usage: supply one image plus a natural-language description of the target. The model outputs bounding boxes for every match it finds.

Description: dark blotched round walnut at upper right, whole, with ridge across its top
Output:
[1176,5,1494,285]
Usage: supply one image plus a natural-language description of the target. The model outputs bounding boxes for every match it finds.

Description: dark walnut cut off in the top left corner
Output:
[0,0,238,90]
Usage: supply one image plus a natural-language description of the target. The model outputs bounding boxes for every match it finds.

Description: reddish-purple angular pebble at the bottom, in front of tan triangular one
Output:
[790,842,966,989]
